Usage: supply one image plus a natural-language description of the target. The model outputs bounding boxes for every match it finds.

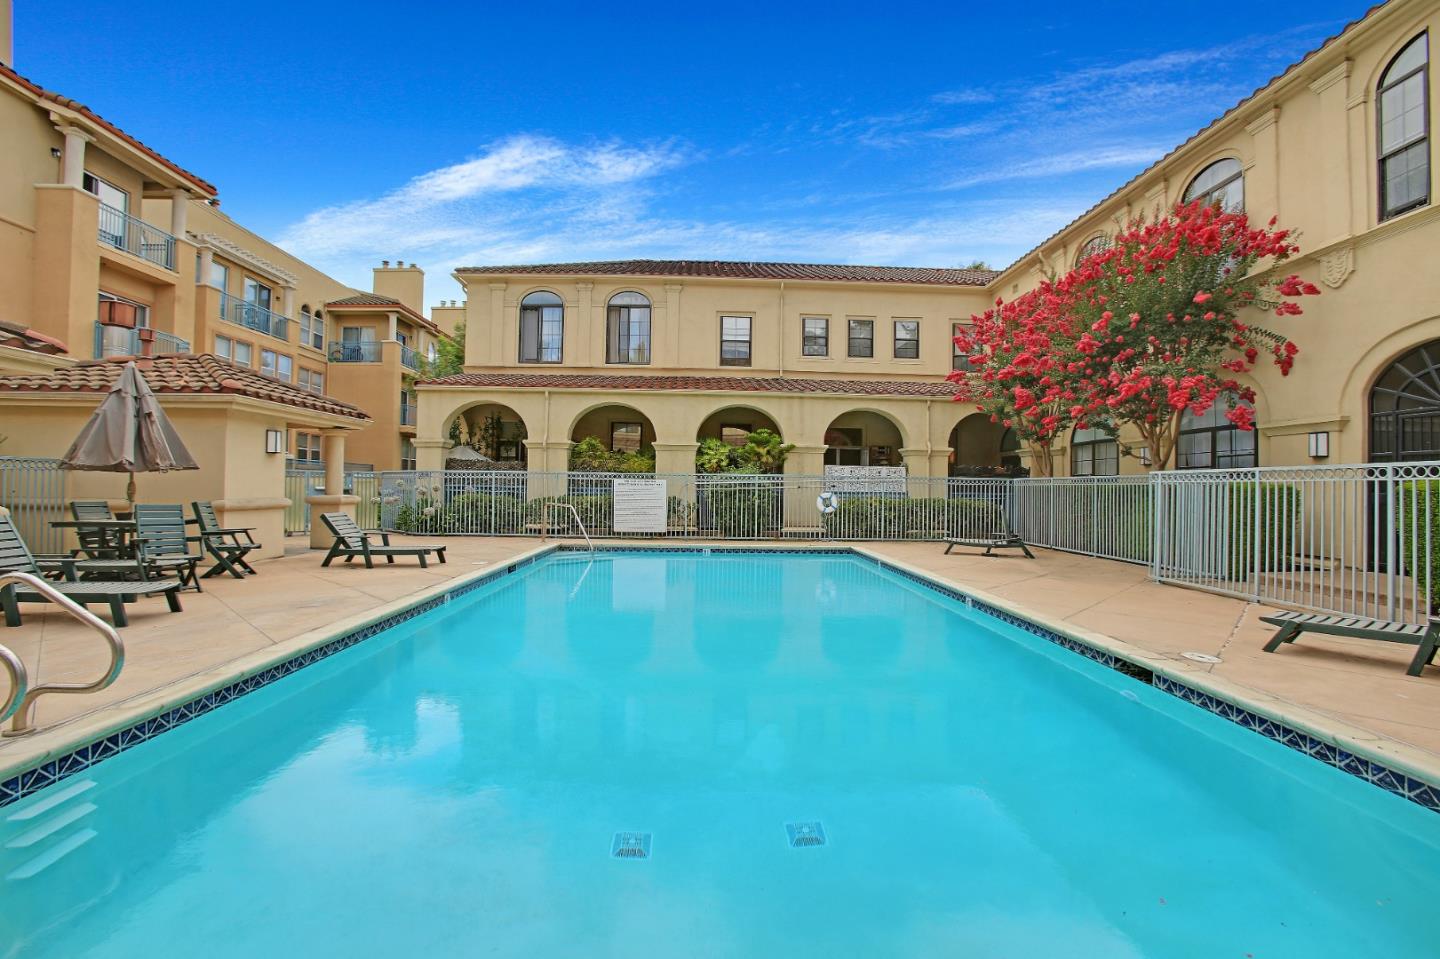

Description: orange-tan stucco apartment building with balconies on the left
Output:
[0,47,446,469]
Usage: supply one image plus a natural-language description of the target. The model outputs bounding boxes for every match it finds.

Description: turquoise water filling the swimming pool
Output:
[0,553,1440,959]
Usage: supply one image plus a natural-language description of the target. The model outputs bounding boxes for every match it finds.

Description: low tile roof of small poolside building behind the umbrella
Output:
[0,353,370,420]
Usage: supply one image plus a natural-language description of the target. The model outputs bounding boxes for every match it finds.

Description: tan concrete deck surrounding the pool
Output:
[0,537,1440,782]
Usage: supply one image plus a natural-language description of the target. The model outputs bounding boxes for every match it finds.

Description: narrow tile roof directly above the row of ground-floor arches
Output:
[419,373,955,397]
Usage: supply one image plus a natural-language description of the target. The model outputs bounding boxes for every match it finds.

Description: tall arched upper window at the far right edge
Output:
[1375,33,1430,220]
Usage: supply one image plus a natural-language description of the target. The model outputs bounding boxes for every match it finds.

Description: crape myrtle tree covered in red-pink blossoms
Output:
[952,202,1320,475]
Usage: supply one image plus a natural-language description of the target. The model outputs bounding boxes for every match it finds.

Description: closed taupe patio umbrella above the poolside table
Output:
[60,361,200,504]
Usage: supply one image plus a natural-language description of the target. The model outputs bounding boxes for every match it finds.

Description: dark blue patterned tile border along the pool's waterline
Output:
[0,544,1440,812]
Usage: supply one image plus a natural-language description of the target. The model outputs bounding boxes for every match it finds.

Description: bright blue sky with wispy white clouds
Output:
[16,0,1365,302]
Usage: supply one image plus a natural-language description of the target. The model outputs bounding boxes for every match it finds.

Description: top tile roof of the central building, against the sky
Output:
[455,259,999,287]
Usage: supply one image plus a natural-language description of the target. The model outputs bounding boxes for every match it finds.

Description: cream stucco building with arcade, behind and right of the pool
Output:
[416,0,1440,475]
